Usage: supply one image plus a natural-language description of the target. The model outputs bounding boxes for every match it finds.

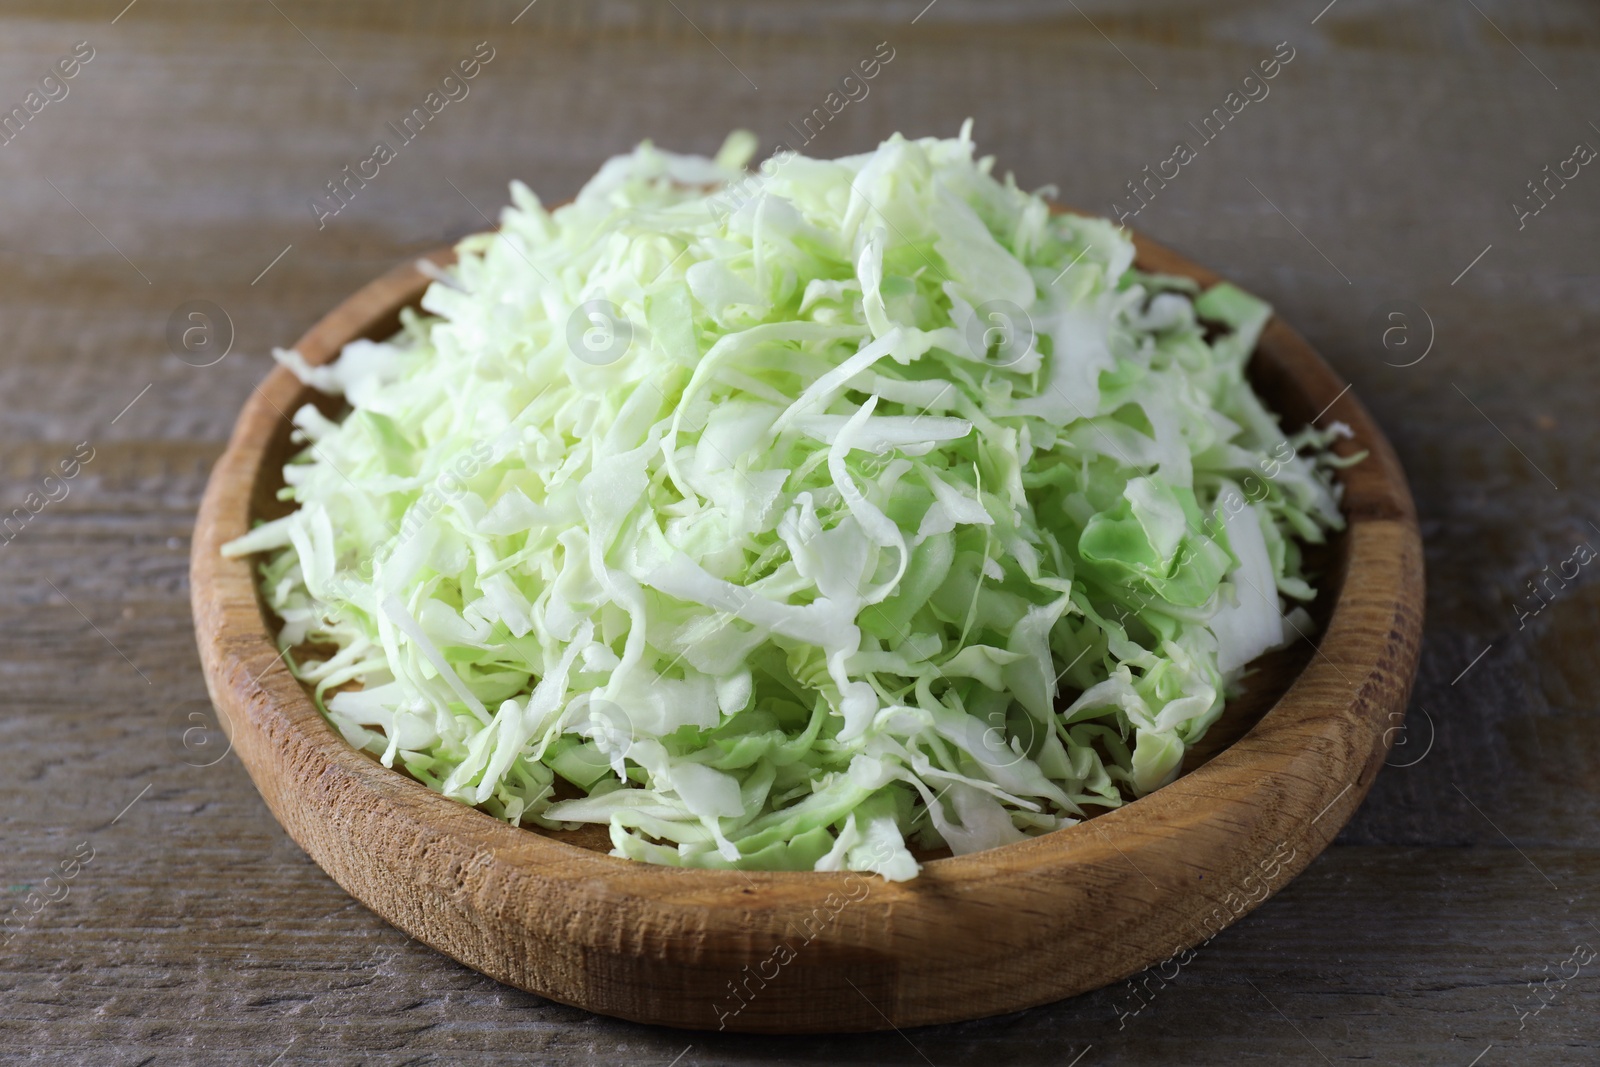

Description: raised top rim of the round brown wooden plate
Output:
[190,219,1422,1029]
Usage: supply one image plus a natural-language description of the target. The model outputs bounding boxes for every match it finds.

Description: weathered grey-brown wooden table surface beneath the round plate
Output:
[0,0,1600,1067]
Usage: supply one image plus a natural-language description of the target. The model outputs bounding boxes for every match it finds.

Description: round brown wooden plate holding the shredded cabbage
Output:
[190,225,1422,1032]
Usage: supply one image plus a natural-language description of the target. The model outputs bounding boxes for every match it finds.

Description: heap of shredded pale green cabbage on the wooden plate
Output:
[226,125,1341,880]
